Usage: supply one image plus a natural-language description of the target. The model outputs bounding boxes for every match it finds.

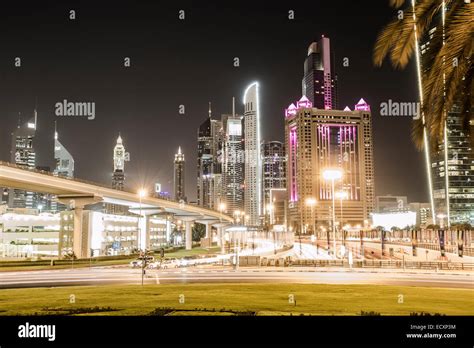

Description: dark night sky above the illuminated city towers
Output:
[0,0,428,202]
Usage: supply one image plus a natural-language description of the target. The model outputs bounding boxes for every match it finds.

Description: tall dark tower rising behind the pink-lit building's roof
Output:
[302,36,337,110]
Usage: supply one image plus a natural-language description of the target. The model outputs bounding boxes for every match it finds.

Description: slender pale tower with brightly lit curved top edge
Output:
[244,82,263,226]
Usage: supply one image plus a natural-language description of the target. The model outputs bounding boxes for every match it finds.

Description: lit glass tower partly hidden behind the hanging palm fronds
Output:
[420,20,474,226]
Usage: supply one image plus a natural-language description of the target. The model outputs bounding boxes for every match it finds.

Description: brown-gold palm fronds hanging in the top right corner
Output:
[373,0,474,149]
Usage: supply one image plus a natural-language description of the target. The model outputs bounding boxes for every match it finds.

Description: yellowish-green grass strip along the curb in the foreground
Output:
[0,284,474,315]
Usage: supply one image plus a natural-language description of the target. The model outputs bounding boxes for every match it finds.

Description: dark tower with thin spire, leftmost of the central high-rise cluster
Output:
[197,103,223,210]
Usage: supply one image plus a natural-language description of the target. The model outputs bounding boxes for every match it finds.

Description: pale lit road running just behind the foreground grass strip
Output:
[0,266,474,289]
